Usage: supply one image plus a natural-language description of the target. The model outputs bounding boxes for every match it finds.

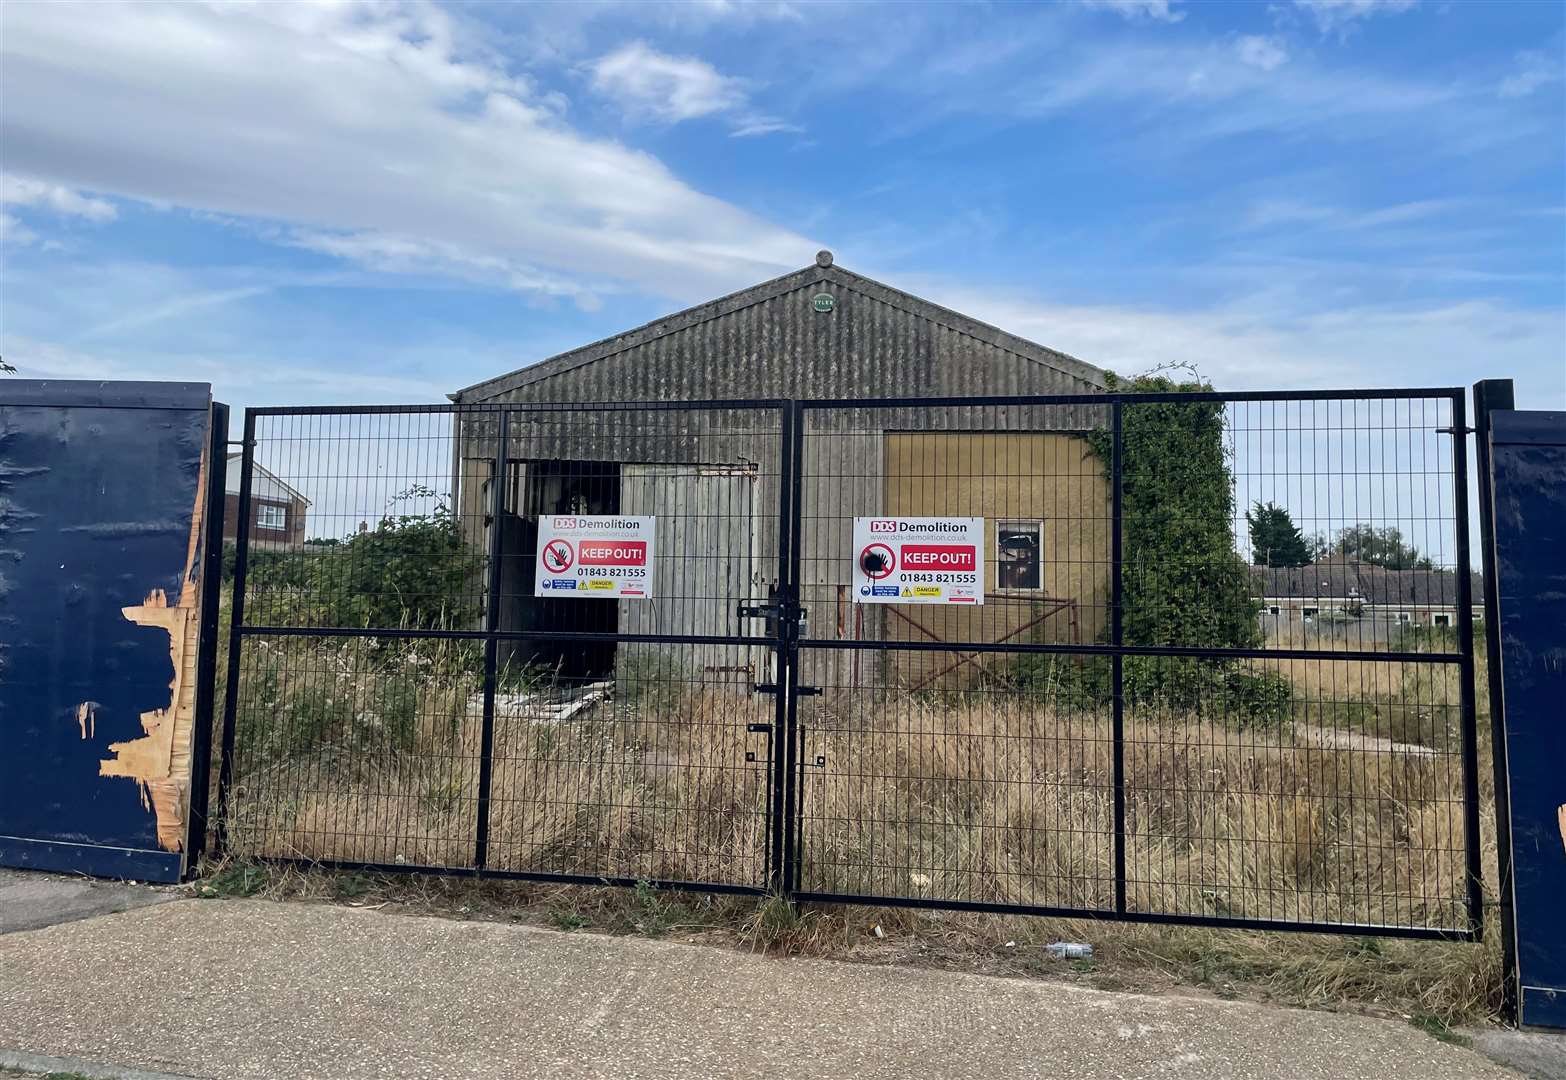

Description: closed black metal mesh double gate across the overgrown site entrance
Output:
[218,390,1481,938]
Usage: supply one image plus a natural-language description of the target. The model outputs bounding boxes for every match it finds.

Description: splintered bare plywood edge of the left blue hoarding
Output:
[99,438,207,851]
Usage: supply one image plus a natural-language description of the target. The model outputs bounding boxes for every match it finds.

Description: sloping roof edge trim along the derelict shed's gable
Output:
[448,254,1104,402]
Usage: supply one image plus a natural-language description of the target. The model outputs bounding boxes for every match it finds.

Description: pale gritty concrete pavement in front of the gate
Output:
[0,900,1517,1080]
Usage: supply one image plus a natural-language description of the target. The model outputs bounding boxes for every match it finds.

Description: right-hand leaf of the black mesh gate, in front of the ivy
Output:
[789,390,1481,938]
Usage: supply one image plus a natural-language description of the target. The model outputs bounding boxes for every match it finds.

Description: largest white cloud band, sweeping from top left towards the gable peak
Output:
[0,3,819,299]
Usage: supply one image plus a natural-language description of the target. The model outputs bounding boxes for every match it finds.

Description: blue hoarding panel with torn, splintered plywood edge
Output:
[0,380,208,880]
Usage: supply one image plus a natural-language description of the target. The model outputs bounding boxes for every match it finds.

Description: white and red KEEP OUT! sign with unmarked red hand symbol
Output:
[532,515,658,599]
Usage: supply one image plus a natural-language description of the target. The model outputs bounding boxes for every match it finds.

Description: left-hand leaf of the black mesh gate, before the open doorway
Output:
[214,402,791,892]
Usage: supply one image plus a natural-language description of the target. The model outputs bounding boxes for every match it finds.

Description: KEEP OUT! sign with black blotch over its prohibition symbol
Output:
[853,518,983,604]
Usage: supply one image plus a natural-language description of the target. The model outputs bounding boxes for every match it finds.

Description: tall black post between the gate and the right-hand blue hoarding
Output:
[1463,379,1517,1024]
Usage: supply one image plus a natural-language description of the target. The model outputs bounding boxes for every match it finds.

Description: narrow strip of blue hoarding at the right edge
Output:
[1491,412,1566,1027]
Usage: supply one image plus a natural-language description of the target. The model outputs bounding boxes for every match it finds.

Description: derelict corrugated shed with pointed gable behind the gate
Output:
[451,252,1110,686]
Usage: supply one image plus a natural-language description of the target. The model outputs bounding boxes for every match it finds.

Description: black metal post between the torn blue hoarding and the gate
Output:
[185,402,229,875]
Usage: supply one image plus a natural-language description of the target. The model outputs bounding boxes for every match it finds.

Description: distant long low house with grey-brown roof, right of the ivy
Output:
[1251,559,1485,629]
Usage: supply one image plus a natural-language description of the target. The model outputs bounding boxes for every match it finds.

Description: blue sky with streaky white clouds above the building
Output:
[0,0,1566,409]
